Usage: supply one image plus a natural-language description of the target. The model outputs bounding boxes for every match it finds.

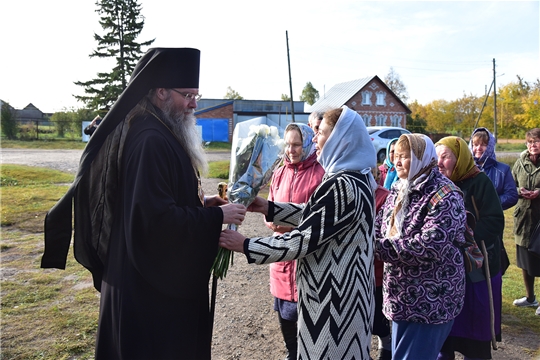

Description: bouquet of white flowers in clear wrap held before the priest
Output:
[212,119,284,279]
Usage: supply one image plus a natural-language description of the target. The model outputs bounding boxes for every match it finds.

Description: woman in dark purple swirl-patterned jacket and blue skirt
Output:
[375,134,466,360]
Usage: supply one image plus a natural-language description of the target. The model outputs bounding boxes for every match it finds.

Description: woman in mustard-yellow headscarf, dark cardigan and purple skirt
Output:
[435,136,504,359]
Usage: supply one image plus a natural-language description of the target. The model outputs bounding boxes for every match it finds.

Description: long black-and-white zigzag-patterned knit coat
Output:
[244,171,375,359]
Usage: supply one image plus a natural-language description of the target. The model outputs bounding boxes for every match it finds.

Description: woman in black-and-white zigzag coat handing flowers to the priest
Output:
[220,106,377,359]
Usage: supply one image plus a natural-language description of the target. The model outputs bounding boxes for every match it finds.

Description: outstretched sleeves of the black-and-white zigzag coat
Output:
[244,177,362,264]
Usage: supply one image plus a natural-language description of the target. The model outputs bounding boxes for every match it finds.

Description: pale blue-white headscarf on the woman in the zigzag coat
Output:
[318,106,377,189]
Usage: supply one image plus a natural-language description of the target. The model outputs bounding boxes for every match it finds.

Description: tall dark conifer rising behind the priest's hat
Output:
[74,0,155,115]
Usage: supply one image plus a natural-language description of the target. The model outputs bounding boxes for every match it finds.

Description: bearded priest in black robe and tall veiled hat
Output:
[42,48,245,359]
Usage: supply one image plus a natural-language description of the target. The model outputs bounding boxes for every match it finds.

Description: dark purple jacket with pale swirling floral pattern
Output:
[375,168,466,324]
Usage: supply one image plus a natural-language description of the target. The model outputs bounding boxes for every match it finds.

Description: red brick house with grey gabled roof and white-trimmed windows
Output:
[309,75,411,128]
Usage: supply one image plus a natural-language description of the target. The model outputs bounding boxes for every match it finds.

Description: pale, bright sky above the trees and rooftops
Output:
[0,0,540,112]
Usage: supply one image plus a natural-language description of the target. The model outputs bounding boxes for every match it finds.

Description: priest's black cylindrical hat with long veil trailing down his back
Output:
[41,48,200,290]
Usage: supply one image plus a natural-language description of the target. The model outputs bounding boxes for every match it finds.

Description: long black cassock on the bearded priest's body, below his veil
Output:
[96,116,223,359]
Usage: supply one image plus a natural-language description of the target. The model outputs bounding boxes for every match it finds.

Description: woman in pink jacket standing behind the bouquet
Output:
[266,122,324,360]
